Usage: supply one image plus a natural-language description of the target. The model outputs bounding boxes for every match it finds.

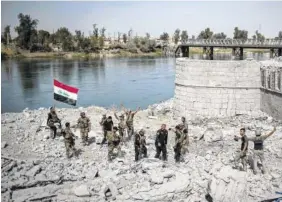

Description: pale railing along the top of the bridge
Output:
[182,39,282,46]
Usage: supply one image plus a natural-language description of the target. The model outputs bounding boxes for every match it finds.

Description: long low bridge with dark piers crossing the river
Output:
[175,39,282,60]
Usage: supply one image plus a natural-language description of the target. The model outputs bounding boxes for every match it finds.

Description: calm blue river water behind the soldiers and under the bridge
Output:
[1,54,269,113]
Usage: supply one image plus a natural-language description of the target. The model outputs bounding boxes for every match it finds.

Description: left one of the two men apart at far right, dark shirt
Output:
[234,128,248,171]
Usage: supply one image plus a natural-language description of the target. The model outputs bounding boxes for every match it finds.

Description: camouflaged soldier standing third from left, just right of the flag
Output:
[77,112,91,146]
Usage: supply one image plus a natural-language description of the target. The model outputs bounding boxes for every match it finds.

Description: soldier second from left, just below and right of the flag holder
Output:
[61,122,76,158]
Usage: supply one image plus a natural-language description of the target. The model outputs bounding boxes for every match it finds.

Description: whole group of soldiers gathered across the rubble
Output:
[47,107,276,174]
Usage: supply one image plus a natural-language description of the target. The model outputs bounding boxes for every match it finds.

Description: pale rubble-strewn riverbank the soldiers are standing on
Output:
[1,99,282,202]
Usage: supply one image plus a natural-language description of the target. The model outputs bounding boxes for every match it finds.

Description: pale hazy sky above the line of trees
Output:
[1,1,282,37]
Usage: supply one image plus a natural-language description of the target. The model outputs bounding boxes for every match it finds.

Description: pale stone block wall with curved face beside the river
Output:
[174,58,282,119]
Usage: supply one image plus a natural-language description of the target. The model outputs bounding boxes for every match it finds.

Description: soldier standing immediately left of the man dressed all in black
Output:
[134,129,147,161]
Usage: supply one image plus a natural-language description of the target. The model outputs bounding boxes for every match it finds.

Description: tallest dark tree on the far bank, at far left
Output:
[15,13,38,49]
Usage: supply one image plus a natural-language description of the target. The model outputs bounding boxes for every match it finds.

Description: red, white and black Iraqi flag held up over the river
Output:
[54,79,78,106]
